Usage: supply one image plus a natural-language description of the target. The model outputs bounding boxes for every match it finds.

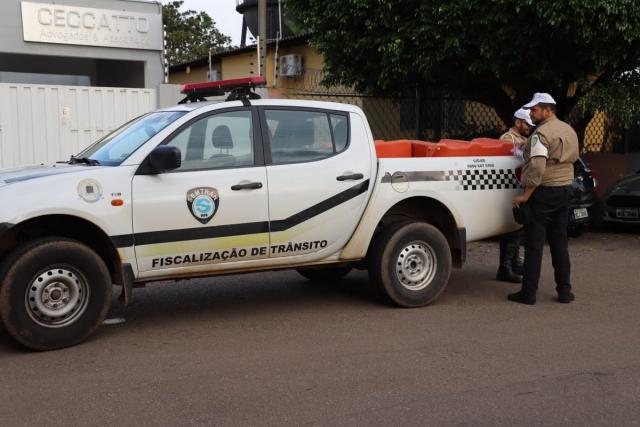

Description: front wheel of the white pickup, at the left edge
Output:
[0,238,111,350]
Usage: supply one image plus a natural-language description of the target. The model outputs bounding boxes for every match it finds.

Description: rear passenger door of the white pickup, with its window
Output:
[260,107,373,262]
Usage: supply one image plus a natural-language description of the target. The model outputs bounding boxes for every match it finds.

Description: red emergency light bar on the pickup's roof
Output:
[179,77,267,104]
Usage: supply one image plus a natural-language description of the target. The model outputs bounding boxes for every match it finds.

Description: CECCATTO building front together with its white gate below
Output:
[0,0,164,167]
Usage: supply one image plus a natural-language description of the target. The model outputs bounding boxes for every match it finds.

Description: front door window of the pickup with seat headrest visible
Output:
[167,110,254,172]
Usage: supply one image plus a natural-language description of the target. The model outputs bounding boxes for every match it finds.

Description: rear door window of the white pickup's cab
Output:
[265,110,349,164]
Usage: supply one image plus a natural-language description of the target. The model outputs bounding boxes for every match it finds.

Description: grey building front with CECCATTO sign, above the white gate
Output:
[0,0,164,89]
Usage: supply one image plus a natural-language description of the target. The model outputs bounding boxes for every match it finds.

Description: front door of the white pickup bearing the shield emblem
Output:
[133,108,269,277]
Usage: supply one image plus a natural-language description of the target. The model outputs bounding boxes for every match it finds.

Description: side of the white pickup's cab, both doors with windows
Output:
[126,101,376,279]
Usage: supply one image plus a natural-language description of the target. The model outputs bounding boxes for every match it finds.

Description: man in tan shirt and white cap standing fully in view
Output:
[508,93,579,304]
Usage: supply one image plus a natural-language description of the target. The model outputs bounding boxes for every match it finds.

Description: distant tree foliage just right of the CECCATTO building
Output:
[162,0,231,65]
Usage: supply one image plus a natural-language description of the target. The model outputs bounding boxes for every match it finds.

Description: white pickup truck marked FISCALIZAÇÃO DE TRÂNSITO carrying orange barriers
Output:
[0,84,519,350]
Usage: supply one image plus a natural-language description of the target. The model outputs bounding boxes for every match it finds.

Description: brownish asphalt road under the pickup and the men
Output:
[0,232,640,426]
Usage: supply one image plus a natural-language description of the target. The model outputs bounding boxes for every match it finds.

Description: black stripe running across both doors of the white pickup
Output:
[111,180,369,248]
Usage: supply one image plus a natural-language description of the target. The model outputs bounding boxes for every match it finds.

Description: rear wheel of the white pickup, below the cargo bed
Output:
[369,222,451,307]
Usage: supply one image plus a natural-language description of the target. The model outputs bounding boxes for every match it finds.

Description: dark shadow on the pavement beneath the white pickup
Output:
[0,271,382,357]
